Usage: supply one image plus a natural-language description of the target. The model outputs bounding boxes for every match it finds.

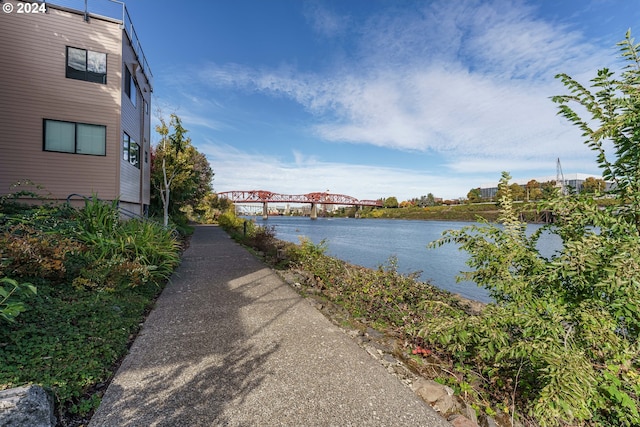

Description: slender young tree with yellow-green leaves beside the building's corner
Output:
[151,114,213,226]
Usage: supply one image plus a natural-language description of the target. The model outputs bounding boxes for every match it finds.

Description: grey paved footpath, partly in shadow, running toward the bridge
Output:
[89,226,451,427]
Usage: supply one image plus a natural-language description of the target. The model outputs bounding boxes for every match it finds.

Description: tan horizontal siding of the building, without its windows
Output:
[0,5,150,211]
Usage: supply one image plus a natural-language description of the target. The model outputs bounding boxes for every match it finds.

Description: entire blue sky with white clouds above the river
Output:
[75,0,640,200]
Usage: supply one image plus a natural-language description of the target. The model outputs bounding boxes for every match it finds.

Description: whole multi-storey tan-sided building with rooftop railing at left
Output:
[0,0,153,214]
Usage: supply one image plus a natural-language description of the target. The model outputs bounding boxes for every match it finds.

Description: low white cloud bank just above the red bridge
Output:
[198,141,478,200]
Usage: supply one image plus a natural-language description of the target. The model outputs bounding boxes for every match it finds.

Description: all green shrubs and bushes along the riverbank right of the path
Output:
[221,29,640,427]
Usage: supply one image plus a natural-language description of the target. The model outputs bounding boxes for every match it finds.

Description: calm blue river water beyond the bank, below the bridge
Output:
[244,216,561,302]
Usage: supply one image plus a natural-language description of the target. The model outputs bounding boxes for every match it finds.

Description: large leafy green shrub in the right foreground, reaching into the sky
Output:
[422,33,640,426]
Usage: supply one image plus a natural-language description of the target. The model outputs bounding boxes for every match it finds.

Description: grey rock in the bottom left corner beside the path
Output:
[0,385,56,427]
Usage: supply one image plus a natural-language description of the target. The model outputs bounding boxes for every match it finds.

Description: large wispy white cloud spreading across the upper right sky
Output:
[194,1,608,159]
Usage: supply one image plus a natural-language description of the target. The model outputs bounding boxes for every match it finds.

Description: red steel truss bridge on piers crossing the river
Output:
[218,190,382,219]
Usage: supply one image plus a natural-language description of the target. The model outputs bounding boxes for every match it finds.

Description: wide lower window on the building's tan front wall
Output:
[44,119,107,156]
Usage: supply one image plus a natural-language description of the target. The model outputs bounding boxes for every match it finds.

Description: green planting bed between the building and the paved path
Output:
[0,198,180,425]
